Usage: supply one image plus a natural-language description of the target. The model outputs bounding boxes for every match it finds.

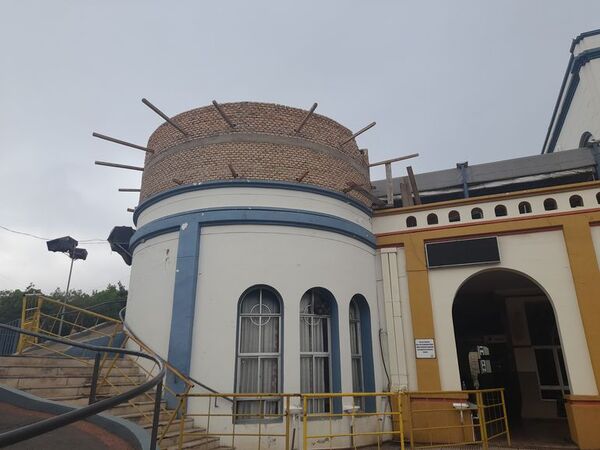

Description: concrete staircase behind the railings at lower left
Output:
[0,355,231,450]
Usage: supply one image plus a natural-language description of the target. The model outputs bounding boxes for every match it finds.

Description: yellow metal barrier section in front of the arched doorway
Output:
[400,389,511,449]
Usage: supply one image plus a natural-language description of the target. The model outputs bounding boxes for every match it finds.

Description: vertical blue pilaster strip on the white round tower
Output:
[165,222,200,406]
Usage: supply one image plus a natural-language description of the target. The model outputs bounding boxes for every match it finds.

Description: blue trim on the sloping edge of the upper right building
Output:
[542,47,600,153]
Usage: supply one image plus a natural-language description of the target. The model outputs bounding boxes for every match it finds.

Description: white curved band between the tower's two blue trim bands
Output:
[137,187,371,230]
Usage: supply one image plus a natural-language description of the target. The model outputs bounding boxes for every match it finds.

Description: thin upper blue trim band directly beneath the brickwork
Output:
[133,179,373,225]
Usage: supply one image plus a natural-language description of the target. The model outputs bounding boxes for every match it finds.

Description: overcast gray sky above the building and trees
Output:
[0,0,600,291]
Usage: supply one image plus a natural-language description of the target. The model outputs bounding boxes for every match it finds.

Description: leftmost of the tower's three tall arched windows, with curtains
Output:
[236,286,282,418]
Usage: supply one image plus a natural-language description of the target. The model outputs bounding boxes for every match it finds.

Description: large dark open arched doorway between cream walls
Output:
[452,269,570,445]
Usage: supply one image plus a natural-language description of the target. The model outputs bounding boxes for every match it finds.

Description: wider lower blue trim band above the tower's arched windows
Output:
[129,208,376,251]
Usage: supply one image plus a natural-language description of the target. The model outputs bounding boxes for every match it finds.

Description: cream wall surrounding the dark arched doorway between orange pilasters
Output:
[429,231,598,395]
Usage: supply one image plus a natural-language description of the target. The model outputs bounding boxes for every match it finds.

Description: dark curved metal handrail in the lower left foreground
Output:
[0,324,166,450]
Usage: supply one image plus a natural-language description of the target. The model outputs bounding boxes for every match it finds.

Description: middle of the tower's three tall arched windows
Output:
[300,288,341,412]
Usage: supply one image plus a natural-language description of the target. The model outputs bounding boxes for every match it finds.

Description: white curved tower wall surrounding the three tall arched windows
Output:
[191,225,382,392]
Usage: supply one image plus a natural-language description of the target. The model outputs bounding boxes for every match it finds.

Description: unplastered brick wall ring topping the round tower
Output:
[140,102,370,206]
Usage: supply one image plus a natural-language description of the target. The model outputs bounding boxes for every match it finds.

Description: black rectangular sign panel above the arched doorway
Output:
[425,237,500,268]
